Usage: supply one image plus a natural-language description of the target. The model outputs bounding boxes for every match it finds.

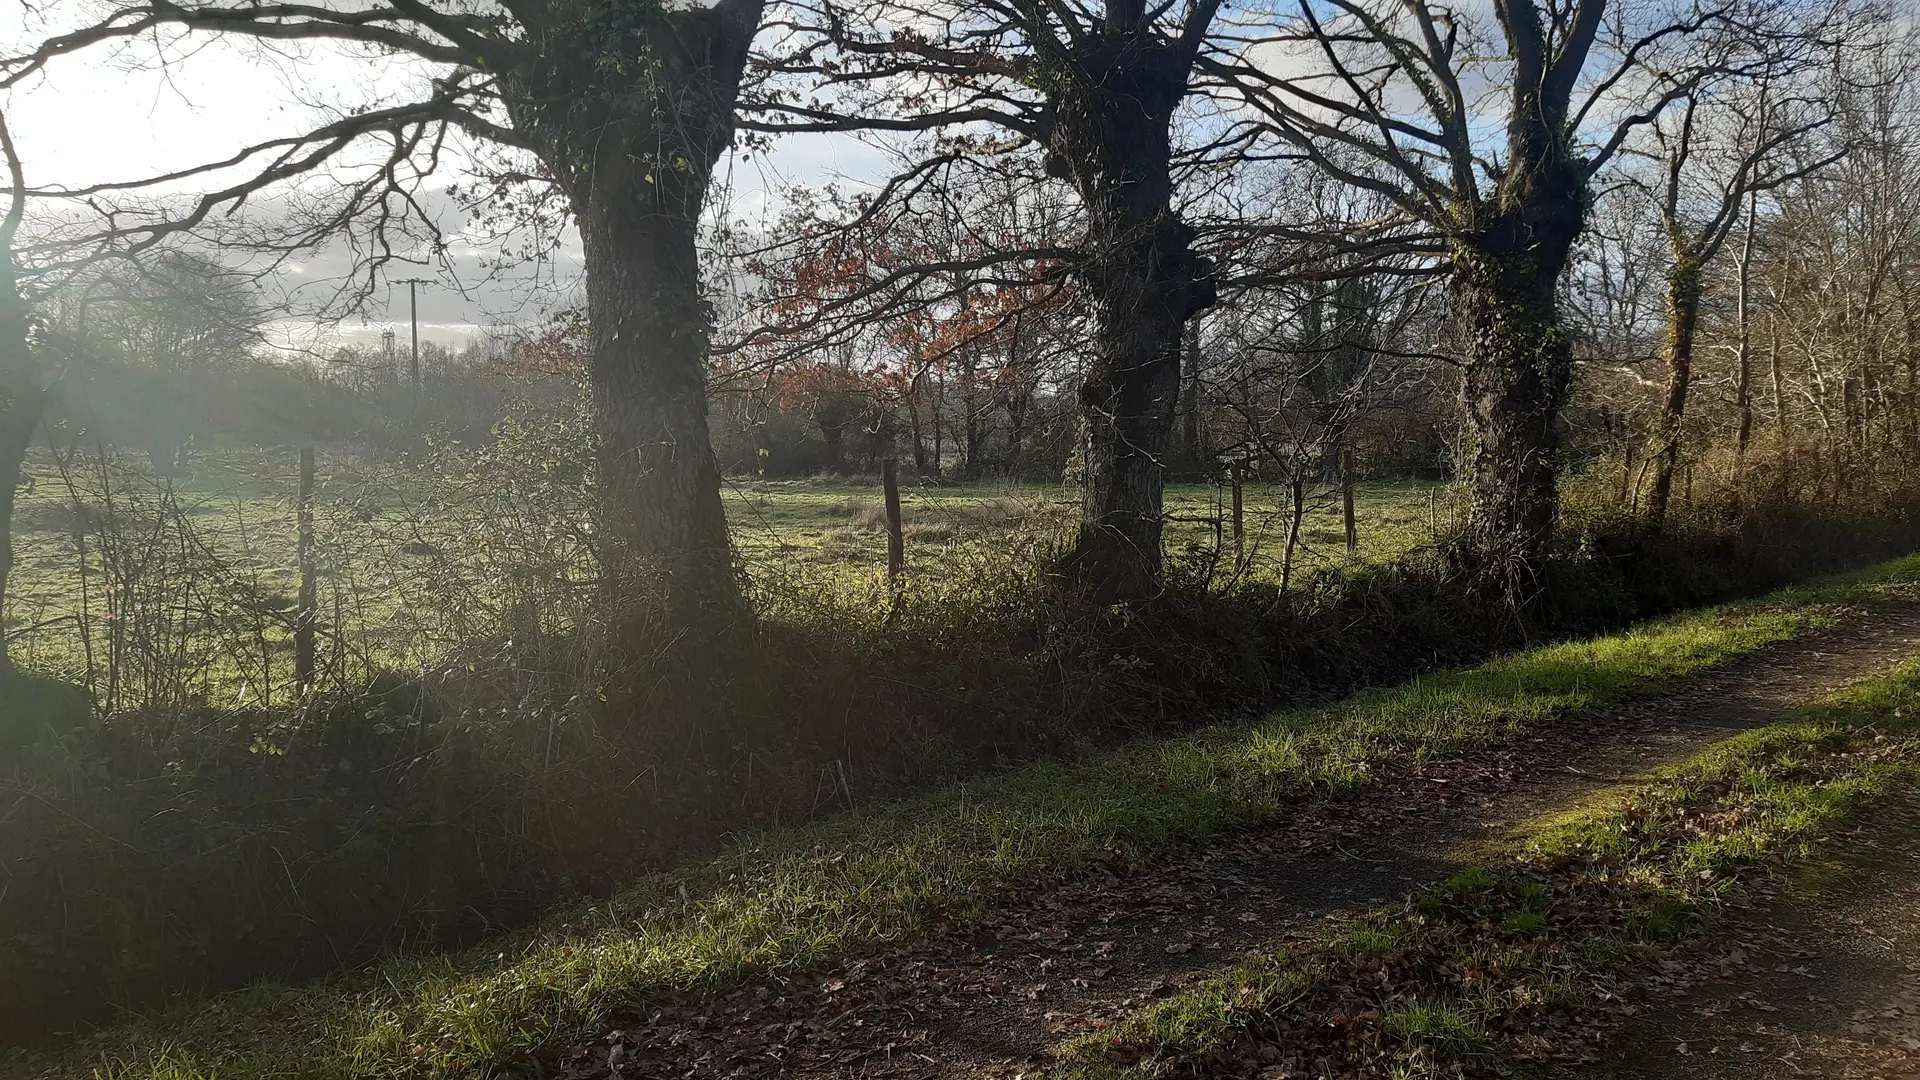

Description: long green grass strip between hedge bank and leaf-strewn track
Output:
[21,557,1920,1080]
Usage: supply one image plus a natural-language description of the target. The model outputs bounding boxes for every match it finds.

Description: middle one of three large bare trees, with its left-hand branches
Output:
[747,0,1223,600]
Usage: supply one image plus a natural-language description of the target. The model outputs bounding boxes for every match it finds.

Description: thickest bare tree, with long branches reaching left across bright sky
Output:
[4,0,764,657]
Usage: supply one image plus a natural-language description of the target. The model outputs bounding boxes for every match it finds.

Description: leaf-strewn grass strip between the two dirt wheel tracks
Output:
[1048,622,1920,1080]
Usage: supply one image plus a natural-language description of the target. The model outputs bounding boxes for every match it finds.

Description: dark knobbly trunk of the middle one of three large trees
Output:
[1048,27,1215,601]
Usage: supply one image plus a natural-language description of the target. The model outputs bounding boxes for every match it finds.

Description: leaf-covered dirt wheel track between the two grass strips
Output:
[543,607,1920,1080]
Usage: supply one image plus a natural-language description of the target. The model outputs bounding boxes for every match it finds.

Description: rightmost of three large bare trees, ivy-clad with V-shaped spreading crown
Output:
[1215,0,1774,559]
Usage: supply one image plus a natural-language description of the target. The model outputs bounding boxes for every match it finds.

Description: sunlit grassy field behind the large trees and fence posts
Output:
[4,441,1446,707]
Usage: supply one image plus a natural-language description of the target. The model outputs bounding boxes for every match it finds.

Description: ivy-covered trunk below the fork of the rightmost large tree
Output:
[1450,231,1576,559]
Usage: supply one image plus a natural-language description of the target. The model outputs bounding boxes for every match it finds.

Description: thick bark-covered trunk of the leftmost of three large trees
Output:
[511,0,762,655]
